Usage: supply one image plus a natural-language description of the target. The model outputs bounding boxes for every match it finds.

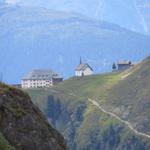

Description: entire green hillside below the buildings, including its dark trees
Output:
[28,55,150,150]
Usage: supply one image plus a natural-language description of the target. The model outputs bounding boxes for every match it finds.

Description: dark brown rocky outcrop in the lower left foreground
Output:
[0,85,67,150]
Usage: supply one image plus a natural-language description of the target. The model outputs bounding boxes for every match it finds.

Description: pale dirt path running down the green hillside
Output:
[88,98,150,139]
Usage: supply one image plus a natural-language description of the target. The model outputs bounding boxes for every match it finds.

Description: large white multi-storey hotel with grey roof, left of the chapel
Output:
[21,70,63,89]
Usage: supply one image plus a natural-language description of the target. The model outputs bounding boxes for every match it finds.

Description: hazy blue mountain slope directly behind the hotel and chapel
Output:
[0,6,150,83]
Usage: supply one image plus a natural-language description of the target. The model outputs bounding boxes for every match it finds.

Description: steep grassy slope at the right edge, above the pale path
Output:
[105,57,150,134]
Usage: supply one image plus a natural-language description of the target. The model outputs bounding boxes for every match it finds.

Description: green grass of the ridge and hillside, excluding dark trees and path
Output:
[27,56,150,149]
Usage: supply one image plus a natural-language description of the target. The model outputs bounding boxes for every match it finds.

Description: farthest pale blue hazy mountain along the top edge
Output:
[3,0,150,33]
